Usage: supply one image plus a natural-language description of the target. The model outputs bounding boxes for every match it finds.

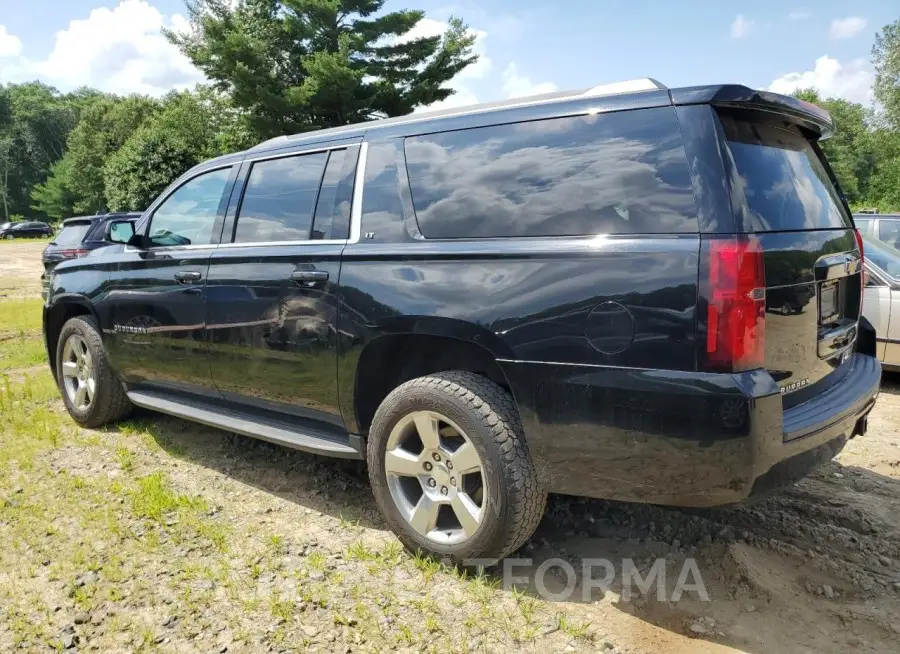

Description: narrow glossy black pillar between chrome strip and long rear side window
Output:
[361,140,407,243]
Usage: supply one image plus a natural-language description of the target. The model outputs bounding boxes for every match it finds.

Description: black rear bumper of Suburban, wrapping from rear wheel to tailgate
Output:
[504,353,881,506]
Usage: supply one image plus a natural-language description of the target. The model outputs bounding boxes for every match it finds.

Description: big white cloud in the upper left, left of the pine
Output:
[0,0,204,95]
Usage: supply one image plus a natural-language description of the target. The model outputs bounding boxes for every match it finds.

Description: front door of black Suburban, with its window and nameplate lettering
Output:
[100,166,233,393]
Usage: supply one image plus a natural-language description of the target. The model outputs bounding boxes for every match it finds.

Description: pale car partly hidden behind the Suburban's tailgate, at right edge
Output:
[863,236,900,371]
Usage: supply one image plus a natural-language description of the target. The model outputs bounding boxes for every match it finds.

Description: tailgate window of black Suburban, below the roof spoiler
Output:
[720,115,852,232]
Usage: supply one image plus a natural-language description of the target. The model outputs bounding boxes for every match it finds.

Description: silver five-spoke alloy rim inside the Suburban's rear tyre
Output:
[384,411,487,545]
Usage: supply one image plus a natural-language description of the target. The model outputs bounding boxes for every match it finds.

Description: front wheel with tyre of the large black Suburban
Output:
[56,316,132,427]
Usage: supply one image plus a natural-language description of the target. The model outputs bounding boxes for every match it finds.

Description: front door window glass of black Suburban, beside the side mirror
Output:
[149,168,231,245]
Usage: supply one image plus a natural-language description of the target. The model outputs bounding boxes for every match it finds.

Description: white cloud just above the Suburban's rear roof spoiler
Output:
[769,55,874,104]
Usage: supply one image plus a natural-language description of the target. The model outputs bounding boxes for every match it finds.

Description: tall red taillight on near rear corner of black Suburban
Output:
[704,236,766,372]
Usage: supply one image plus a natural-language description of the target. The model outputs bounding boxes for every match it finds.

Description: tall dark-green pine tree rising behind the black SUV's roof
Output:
[166,0,477,136]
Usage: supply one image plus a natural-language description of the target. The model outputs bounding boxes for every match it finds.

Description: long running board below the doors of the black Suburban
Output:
[127,391,365,459]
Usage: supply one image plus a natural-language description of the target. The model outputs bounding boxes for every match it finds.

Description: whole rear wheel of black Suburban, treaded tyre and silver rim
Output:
[366,372,547,563]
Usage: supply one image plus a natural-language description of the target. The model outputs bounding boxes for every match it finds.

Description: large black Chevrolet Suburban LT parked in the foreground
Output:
[44,80,881,560]
